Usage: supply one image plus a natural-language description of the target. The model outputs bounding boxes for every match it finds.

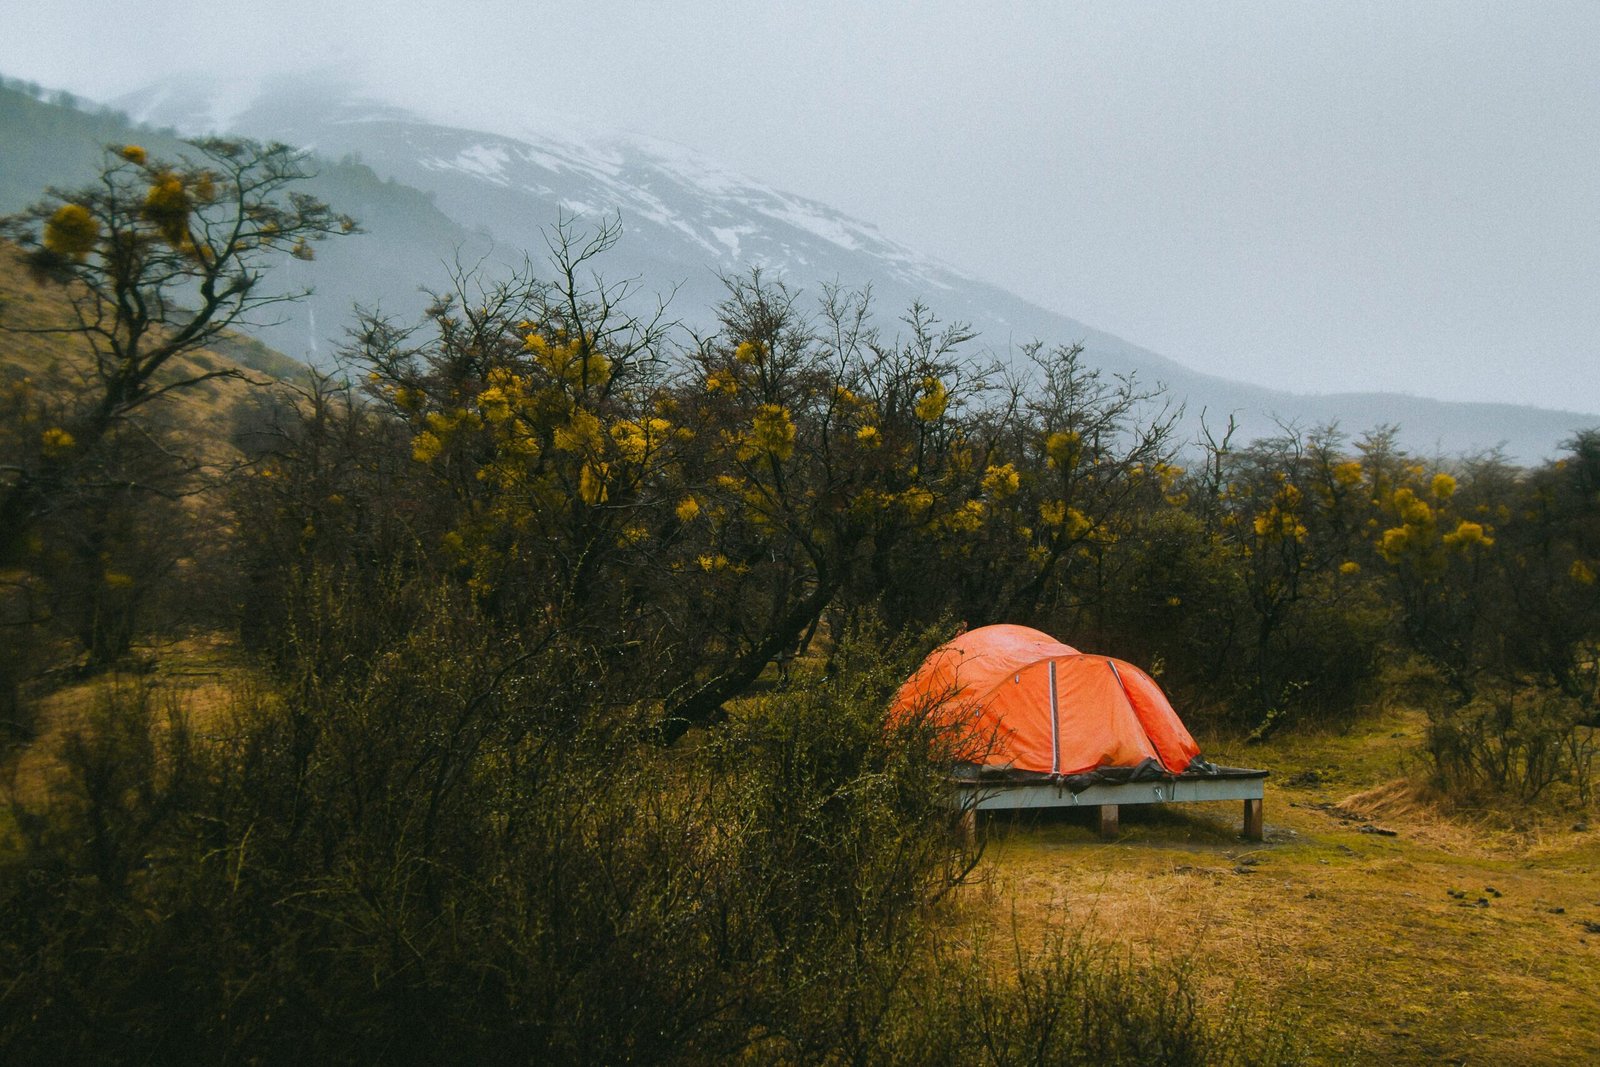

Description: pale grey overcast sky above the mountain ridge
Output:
[0,0,1600,413]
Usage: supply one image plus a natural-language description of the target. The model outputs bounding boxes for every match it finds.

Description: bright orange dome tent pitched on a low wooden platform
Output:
[894,625,1200,776]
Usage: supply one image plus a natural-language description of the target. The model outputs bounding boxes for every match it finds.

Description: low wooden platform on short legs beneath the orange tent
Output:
[955,773,1266,841]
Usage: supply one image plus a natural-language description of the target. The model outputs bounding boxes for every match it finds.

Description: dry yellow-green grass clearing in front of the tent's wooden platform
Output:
[963,715,1600,1064]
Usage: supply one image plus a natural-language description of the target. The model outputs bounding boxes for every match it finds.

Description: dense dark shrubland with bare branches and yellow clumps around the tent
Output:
[0,144,1600,1062]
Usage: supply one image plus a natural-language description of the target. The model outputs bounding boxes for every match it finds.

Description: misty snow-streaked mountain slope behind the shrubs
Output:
[115,78,1600,459]
